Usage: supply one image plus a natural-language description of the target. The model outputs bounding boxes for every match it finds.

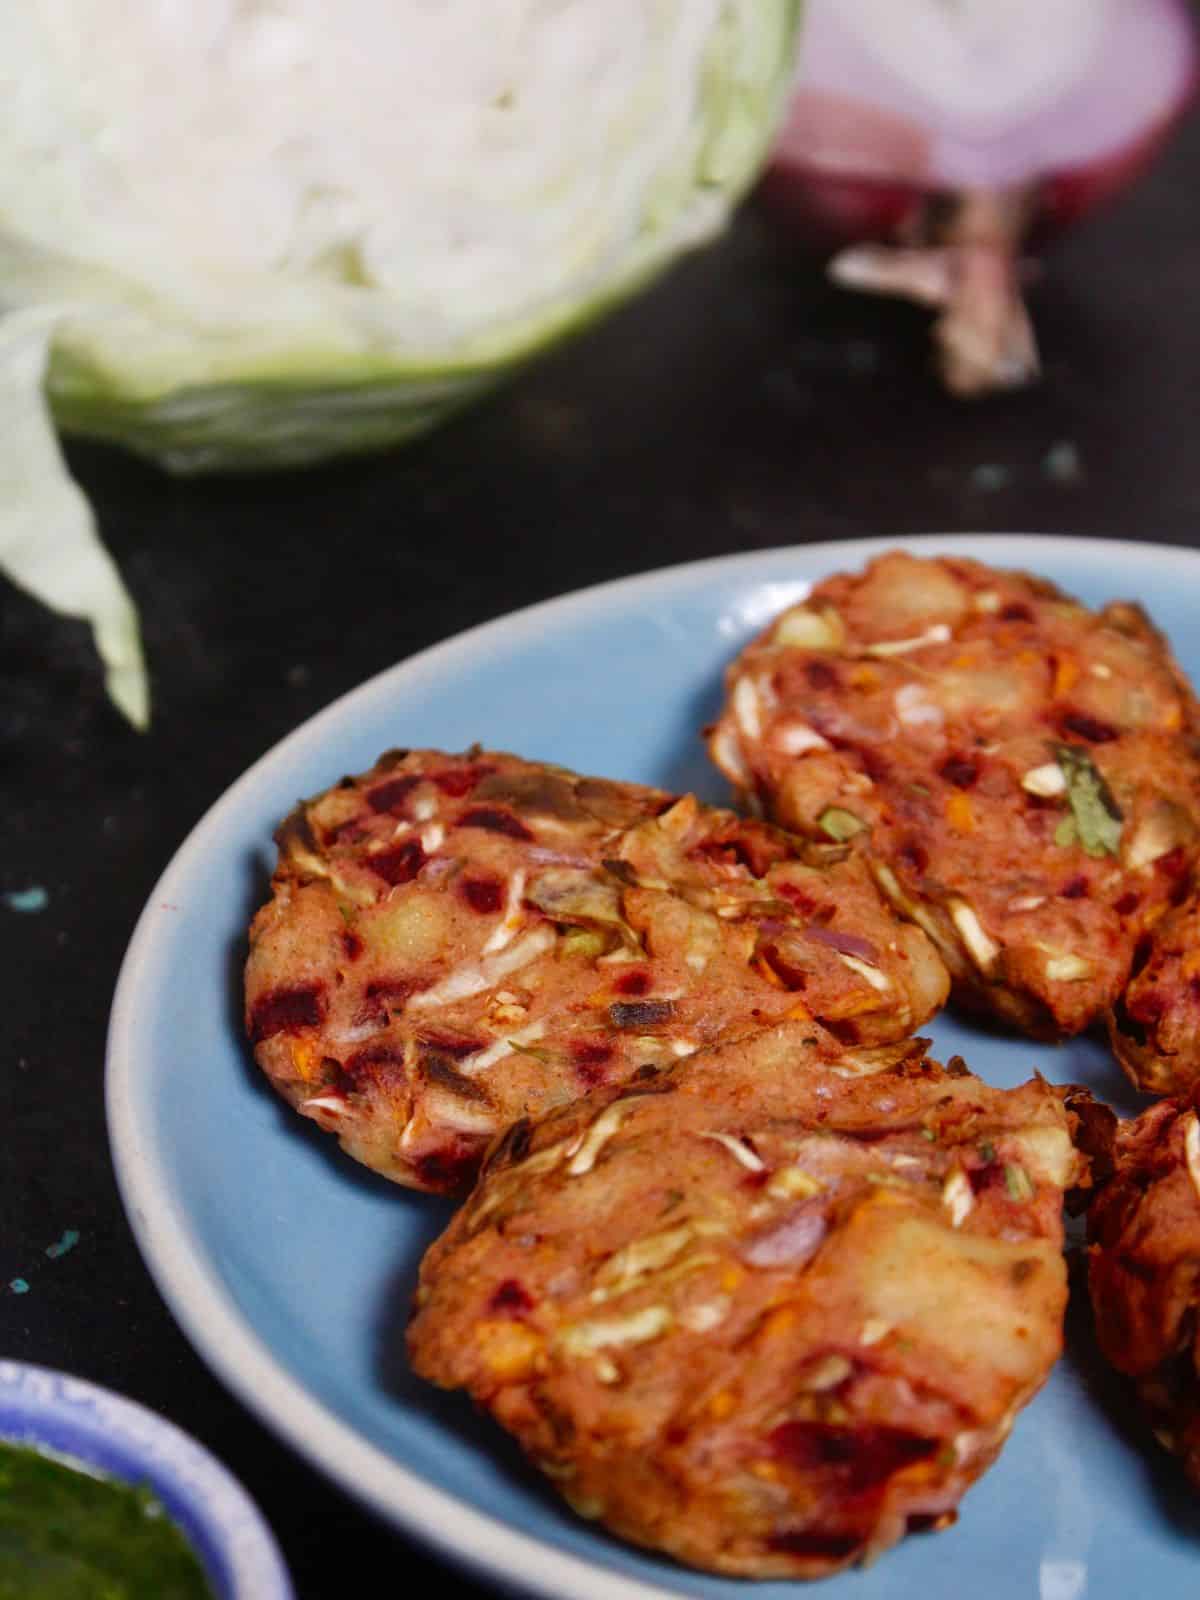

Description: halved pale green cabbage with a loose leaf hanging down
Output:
[0,0,800,725]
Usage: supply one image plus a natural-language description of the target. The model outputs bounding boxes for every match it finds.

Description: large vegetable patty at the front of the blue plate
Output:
[410,1022,1077,1578]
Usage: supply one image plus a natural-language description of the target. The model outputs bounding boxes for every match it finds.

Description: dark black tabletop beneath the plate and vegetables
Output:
[0,106,1200,1600]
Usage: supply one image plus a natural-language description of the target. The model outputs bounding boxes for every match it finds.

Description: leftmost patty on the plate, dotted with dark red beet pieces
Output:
[246,750,949,1190]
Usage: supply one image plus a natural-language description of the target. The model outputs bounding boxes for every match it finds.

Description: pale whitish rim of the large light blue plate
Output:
[106,531,1200,1600]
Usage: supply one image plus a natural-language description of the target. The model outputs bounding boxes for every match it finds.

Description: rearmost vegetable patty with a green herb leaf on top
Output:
[709,552,1200,1049]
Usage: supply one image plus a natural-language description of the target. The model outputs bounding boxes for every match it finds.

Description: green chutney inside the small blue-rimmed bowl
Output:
[0,1443,213,1600]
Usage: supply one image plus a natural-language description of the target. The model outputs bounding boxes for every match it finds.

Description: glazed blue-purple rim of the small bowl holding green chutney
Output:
[0,1362,291,1600]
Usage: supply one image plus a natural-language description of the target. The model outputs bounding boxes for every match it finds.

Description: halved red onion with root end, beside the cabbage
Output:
[760,0,1197,394]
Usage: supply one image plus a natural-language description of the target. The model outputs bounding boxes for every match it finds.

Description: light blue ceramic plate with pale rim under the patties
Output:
[109,536,1200,1600]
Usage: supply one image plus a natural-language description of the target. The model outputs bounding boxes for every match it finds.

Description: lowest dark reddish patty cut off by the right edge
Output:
[1088,1091,1200,1490]
